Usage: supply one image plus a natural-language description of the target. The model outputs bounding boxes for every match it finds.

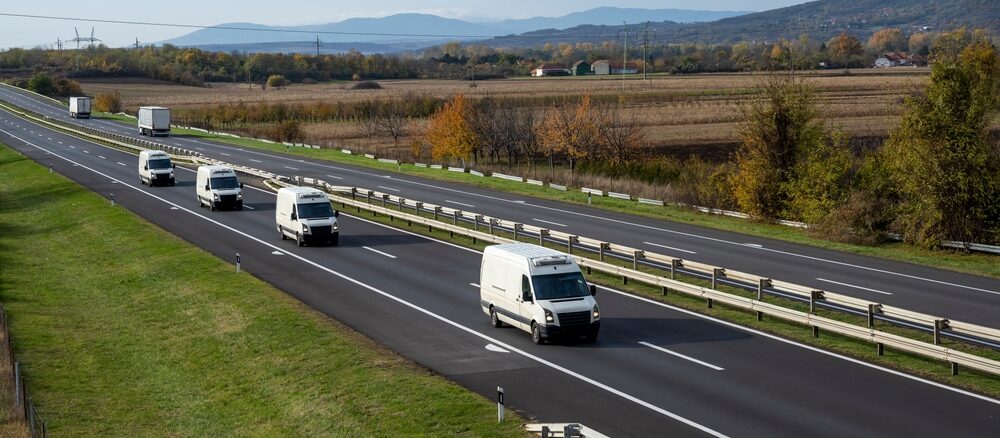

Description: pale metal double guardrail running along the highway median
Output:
[0,96,1000,375]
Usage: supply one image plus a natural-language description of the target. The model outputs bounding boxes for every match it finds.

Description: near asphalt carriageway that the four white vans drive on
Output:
[0,98,1000,437]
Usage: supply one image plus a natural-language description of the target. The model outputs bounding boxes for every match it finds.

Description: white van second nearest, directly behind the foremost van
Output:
[274,187,340,246]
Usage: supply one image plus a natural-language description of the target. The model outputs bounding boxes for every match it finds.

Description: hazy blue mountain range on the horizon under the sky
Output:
[162,7,747,50]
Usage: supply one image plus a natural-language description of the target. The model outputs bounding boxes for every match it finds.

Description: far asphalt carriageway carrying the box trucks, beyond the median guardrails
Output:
[0,86,1000,327]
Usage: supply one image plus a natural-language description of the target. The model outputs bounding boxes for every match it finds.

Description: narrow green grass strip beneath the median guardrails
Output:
[332,198,1000,397]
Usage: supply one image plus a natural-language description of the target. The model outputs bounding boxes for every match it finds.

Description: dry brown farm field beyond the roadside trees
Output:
[81,68,929,159]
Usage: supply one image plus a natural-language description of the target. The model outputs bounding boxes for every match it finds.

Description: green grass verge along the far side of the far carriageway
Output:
[95,114,1000,278]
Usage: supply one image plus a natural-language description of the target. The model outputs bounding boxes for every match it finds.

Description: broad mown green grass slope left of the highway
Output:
[0,142,524,436]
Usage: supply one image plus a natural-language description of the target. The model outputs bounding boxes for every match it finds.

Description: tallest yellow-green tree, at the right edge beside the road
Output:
[886,29,1000,247]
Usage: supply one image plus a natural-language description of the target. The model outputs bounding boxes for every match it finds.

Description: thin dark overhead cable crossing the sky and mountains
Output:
[0,12,656,40]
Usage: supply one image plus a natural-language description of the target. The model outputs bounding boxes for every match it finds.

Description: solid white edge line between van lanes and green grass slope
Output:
[0,129,727,438]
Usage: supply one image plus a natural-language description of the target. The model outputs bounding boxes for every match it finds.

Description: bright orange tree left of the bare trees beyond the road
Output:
[427,94,477,164]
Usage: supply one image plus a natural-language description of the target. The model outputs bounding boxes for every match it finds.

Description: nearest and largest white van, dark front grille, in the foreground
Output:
[479,243,601,344]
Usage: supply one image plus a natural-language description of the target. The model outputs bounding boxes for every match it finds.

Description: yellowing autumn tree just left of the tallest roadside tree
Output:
[732,74,823,218]
